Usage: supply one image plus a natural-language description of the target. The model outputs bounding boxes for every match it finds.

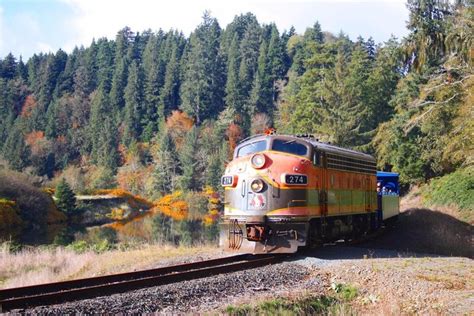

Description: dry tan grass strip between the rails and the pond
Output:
[0,244,219,288]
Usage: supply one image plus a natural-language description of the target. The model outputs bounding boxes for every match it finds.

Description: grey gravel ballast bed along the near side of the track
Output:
[25,262,311,314]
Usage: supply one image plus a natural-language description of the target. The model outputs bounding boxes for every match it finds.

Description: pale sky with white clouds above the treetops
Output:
[0,0,408,61]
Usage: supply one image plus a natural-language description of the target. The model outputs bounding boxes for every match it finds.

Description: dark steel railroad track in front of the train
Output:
[0,254,287,312]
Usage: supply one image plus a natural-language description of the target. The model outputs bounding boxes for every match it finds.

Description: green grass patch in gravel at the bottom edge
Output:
[225,283,358,316]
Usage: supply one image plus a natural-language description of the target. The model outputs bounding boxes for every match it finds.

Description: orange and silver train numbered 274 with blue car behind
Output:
[220,131,400,254]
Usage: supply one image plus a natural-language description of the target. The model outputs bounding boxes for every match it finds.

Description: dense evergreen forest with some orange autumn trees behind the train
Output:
[0,0,474,244]
